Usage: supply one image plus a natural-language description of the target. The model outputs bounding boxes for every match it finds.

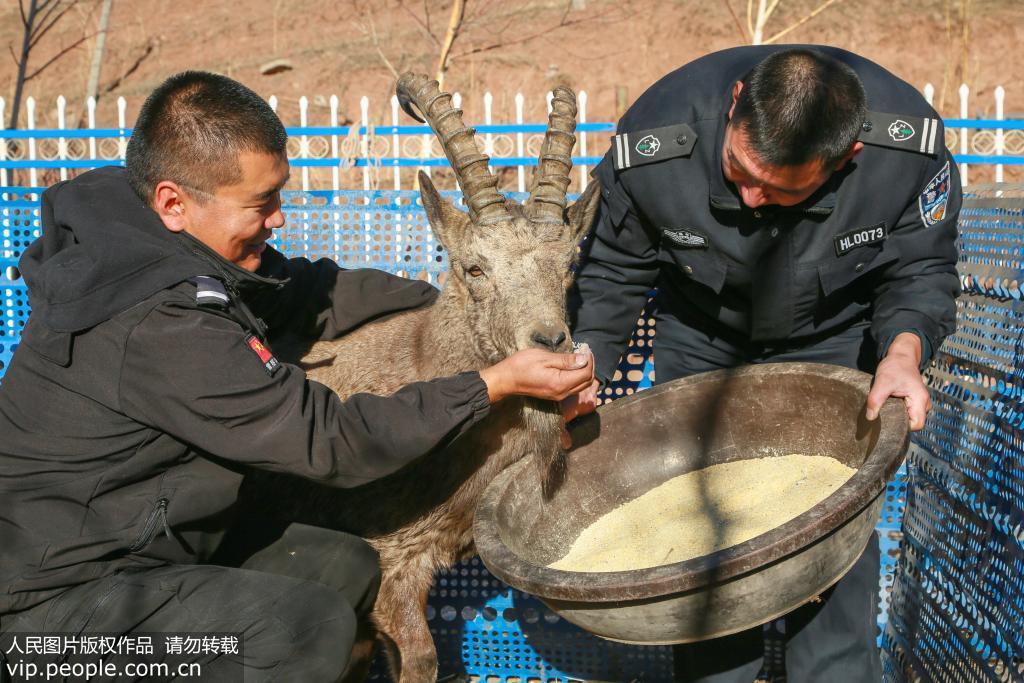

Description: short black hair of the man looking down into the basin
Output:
[731,48,867,169]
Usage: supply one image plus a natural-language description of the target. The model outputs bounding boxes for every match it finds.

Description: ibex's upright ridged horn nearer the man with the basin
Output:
[524,85,577,223]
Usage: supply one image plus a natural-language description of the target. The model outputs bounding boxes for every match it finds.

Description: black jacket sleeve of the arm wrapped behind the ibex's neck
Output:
[249,249,437,339]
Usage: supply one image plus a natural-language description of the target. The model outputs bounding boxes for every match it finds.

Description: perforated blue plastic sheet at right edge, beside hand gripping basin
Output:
[883,185,1024,683]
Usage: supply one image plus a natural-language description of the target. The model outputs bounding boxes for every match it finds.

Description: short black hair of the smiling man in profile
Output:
[125,71,288,204]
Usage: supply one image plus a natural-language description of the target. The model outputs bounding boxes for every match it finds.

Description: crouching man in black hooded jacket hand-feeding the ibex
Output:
[0,73,593,682]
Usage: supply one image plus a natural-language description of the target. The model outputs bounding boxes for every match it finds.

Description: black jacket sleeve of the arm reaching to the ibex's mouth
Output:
[120,302,489,486]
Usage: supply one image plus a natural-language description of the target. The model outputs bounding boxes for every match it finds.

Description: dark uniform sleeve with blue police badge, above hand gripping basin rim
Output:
[871,147,963,369]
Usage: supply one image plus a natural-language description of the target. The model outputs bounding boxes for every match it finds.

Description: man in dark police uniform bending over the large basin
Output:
[573,46,961,683]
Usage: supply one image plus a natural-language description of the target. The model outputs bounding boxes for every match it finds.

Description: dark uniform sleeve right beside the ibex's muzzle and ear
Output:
[572,157,658,384]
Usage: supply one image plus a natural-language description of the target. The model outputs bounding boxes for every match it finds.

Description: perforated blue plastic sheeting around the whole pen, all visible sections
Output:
[9,186,1007,683]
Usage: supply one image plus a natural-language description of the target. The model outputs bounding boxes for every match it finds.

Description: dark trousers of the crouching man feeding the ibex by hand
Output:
[0,521,380,683]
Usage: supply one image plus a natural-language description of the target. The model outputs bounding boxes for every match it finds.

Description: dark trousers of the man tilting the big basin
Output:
[654,302,882,683]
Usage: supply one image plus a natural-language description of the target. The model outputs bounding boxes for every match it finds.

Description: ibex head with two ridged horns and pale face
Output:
[396,74,600,362]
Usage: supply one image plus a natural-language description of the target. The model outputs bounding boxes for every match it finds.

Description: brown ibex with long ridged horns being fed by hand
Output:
[253,74,599,683]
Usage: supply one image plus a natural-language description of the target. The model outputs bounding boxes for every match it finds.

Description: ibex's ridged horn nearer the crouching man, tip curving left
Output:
[395,73,512,224]
